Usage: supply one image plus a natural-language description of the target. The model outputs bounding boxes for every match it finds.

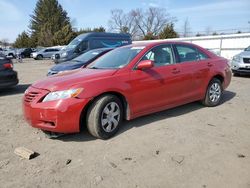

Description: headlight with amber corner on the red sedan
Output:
[43,88,83,102]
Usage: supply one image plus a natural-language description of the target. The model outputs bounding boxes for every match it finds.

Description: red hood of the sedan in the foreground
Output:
[32,68,117,91]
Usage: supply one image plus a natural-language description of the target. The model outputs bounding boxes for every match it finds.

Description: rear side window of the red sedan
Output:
[176,45,208,62]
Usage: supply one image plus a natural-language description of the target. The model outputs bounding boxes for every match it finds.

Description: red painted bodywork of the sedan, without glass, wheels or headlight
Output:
[23,42,231,133]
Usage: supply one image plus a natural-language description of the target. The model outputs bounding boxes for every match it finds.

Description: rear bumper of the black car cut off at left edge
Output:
[0,69,18,88]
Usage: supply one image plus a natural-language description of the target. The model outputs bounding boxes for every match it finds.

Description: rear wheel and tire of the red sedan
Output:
[202,78,223,107]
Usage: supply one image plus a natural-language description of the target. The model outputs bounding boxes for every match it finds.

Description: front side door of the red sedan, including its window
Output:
[131,45,182,116]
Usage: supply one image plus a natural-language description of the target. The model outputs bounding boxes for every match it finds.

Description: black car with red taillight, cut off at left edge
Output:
[0,54,18,89]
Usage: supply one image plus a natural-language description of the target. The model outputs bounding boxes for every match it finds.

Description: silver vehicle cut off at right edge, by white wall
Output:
[231,46,250,76]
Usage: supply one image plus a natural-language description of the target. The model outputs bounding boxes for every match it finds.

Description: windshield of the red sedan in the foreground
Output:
[87,47,144,69]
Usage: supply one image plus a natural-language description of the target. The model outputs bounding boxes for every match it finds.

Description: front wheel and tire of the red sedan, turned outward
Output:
[86,95,123,139]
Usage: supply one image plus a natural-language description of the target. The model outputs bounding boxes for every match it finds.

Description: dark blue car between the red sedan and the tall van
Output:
[47,48,112,76]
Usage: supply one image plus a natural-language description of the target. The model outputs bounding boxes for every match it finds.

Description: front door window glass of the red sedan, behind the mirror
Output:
[142,46,174,67]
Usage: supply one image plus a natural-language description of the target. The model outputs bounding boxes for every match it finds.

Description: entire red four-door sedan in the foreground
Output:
[23,42,231,139]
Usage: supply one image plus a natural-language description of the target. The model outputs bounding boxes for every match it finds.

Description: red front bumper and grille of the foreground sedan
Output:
[23,87,90,133]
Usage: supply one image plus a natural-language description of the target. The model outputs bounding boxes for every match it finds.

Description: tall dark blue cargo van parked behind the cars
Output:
[54,32,132,63]
